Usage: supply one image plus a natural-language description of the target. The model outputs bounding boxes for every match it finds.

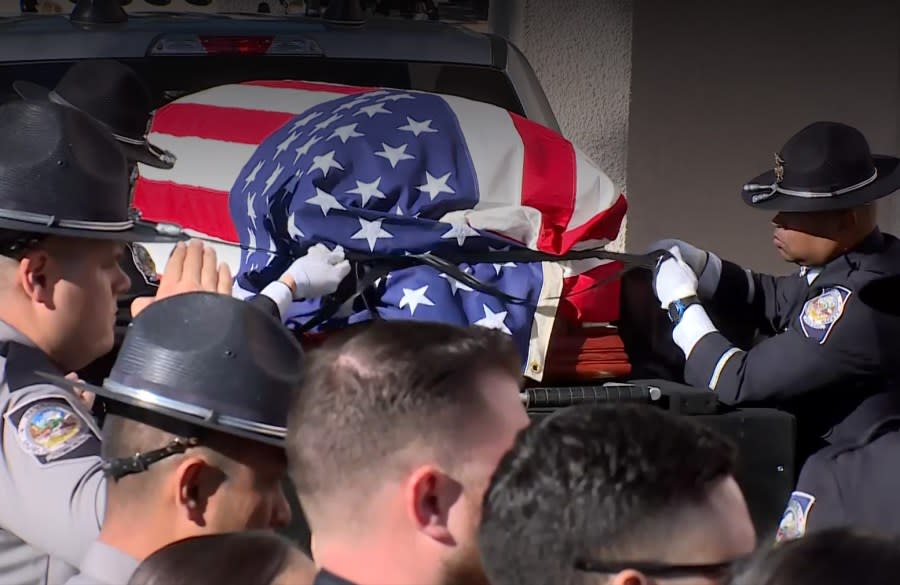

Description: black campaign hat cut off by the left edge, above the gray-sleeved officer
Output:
[0,101,186,242]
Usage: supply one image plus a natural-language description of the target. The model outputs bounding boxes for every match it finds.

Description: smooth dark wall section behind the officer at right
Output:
[628,0,900,273]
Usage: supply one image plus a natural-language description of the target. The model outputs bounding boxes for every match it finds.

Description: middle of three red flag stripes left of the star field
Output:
[151,103,294,145]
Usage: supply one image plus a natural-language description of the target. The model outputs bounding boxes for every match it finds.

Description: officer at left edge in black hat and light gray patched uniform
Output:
[0,102,190,585]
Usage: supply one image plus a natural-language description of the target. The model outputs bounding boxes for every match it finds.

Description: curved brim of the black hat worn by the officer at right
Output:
[741,154,900,212]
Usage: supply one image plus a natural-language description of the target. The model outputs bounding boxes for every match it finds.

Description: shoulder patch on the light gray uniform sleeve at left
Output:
[6,398,100,465]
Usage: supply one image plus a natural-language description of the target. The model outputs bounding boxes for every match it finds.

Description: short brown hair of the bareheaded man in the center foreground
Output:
[286,321,522,518]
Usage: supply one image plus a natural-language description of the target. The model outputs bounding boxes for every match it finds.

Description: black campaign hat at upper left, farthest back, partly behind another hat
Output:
[13,60,175,169]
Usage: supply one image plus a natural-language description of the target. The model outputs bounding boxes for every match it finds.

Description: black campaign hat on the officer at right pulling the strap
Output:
[742,122,900,211]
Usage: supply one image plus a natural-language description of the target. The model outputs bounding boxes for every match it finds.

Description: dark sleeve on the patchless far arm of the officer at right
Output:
[709,261,803,332]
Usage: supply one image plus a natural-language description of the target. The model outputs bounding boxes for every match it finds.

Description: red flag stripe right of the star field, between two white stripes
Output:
[509,113,576,254]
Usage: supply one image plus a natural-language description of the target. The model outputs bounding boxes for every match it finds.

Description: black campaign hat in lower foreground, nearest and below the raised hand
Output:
[41,293,303,446]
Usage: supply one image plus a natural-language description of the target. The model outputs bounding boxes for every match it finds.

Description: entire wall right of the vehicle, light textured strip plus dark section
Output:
[492,0,900,272]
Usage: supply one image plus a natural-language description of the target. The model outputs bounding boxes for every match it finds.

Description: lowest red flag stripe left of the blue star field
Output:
[134,177,238,242]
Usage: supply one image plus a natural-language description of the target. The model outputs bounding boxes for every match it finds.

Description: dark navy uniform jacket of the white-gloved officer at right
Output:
[685,230,900,440]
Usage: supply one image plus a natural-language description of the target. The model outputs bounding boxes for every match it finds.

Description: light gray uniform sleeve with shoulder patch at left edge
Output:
[0,385,106,566]
